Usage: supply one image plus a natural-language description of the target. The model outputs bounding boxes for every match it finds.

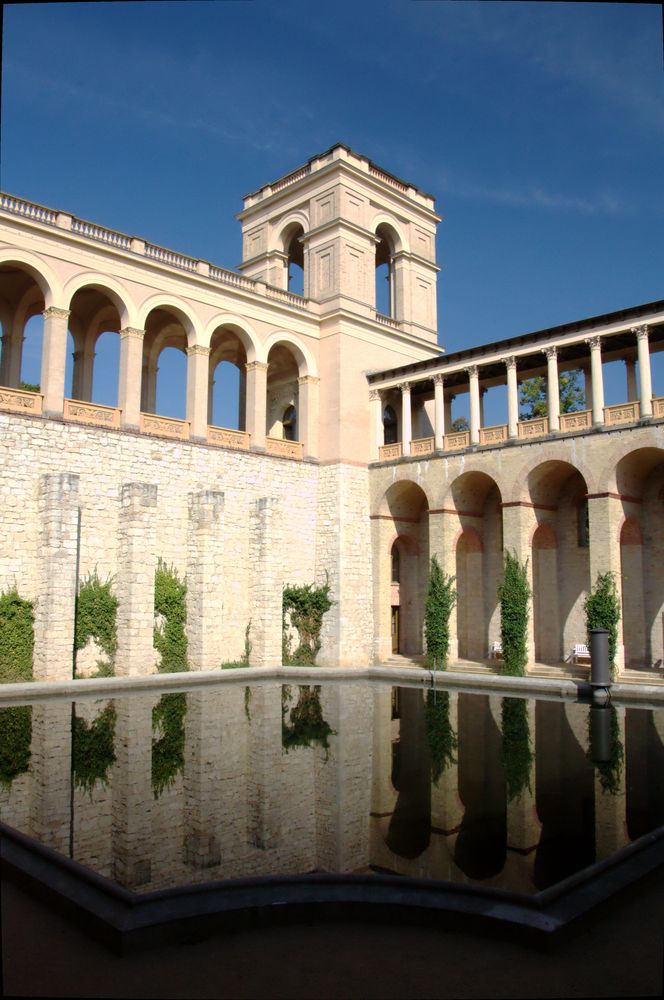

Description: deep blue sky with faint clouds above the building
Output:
[0,0,664,422]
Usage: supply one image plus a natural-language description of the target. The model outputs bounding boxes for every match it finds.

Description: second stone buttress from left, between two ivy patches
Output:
[115,483,157,677]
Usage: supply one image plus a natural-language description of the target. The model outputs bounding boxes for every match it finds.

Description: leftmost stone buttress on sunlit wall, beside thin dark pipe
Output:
[33,472,79,681]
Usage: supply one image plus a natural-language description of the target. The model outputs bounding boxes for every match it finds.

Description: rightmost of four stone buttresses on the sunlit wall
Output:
[249,497,283,667]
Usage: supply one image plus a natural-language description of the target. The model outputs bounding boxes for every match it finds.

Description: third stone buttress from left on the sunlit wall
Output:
[186,490,224,670]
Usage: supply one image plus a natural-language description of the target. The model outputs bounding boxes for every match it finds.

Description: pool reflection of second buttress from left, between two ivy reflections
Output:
[113,694,158,888]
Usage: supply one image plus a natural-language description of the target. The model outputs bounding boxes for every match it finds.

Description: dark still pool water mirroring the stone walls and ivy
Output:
[0,681,664,893]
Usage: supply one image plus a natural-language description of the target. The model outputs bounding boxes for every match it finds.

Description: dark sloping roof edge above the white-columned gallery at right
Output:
[367,299,664,383]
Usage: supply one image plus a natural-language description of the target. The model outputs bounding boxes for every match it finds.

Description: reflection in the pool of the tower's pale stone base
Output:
[315,682,374,872]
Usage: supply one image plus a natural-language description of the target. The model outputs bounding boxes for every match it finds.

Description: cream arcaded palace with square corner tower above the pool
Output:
[0,145,664,680]
